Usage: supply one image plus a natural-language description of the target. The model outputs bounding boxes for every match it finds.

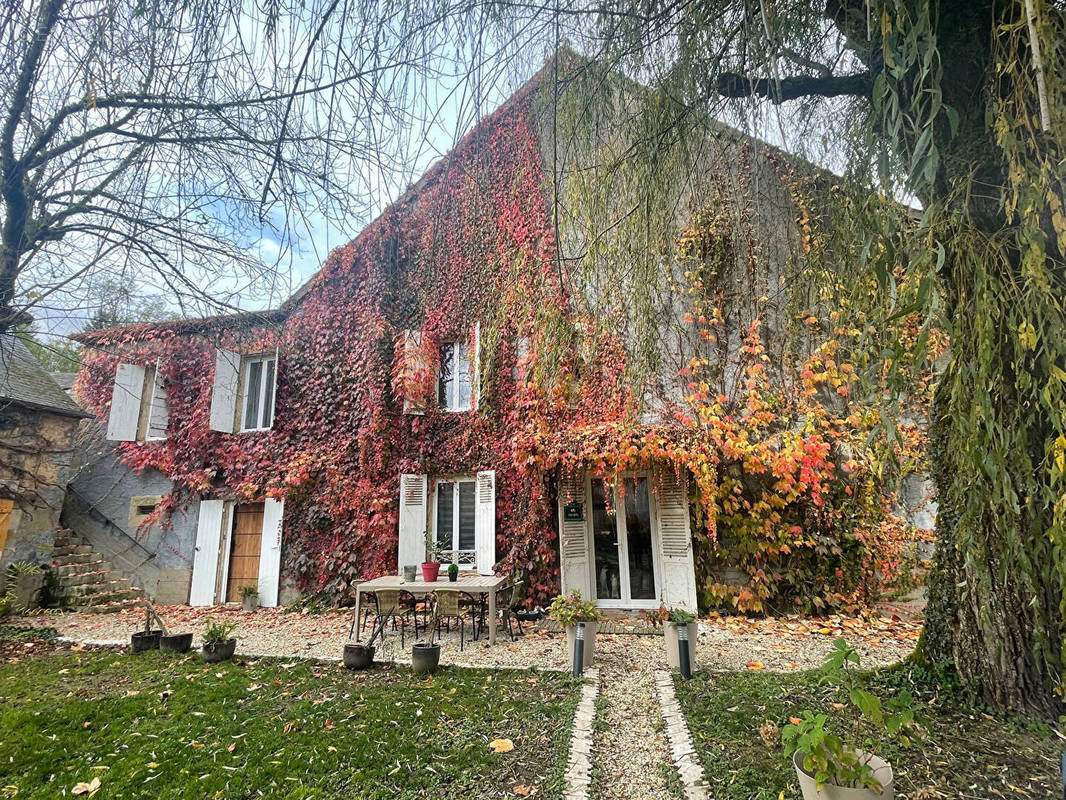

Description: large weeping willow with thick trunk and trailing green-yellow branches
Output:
[528,0,1066,711]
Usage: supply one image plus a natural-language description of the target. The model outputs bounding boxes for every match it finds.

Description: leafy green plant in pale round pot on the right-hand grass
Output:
[781,639,917,800]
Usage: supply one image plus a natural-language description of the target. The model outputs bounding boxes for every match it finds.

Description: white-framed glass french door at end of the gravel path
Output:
[588,475,659,608]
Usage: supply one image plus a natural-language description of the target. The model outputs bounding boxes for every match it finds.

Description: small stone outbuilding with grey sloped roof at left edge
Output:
[0,335,92,569]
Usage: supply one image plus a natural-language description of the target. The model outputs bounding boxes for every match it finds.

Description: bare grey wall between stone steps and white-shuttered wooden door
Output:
[62,421,199,604]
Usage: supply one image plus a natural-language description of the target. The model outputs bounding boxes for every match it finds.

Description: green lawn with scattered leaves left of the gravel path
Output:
[0,639,580,800]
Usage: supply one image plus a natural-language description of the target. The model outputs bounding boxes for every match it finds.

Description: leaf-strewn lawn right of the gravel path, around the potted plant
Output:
[677,668,1066,800]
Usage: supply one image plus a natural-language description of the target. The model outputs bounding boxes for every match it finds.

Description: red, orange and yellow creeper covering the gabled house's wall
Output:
[78,62,929,611]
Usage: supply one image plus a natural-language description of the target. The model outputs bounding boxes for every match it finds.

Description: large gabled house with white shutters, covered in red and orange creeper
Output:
[66,56,925,609]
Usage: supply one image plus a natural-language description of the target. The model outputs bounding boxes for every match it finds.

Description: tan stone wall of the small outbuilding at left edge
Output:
[0,404,80,567]
